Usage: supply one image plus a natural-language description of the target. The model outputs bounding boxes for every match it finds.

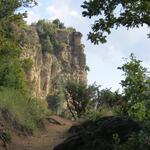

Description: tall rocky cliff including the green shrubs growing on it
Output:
[19,22,87,99]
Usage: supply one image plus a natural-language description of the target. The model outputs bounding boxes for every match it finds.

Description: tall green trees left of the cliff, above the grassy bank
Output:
[0,0,37,90]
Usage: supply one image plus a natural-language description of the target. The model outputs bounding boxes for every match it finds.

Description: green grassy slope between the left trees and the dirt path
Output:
[0,87,50,132]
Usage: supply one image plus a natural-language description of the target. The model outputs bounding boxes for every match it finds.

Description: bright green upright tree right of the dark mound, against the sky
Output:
[118,54,150,118]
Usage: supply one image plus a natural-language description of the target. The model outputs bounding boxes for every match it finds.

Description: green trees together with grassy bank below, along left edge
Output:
[0,0,49,134]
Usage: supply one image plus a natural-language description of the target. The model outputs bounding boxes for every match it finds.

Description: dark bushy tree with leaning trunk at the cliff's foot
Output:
[65,81,98,119]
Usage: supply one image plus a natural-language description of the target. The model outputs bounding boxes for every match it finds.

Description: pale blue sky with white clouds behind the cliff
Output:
[22,0,150,91]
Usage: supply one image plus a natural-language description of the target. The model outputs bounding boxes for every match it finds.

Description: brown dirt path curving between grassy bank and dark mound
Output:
[5,116,74,150]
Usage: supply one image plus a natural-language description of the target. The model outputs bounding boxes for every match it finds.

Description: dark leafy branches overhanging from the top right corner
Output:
[82,0,150,44]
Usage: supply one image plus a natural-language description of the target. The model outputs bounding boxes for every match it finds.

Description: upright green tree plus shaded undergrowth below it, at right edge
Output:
[110,54,150,150]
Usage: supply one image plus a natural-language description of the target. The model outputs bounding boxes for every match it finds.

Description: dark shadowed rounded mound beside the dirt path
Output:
[54,117,142,150]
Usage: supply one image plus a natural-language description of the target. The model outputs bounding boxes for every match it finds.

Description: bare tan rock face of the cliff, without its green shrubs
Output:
[21,27,87,99]
